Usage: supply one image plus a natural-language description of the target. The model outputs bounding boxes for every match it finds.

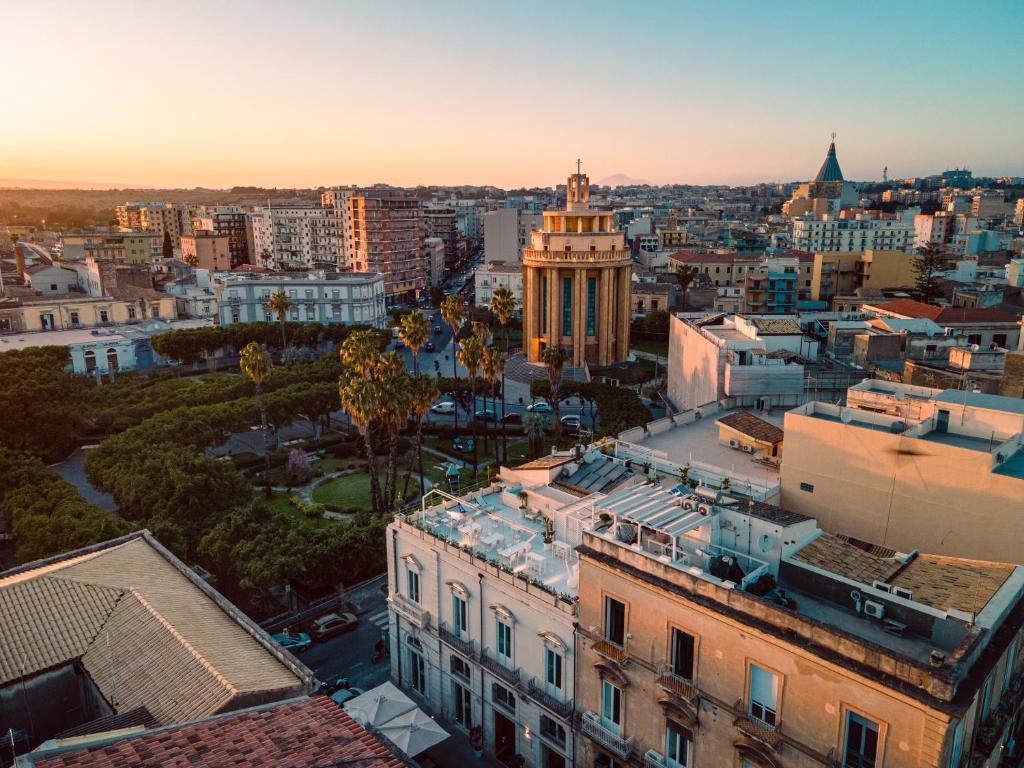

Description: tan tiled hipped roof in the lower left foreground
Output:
[0,531,313,724]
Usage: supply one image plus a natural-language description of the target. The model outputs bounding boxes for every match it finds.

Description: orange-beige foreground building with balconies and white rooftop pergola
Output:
[575,481,1024,768]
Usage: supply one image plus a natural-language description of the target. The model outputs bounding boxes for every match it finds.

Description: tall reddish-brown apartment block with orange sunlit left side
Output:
[347,186,430,303]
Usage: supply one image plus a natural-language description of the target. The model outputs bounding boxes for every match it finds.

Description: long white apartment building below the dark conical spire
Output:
[793,216,914,253]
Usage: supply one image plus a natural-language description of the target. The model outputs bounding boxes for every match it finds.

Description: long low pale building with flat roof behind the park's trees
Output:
[216,271,387,328]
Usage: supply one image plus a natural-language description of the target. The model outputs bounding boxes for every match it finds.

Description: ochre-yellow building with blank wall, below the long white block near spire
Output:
[811,250,916,301]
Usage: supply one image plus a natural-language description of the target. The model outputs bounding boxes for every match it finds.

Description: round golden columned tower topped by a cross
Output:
[522,164,633,366]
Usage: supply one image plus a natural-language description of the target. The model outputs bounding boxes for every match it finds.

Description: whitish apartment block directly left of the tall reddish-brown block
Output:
[247,189,351,269]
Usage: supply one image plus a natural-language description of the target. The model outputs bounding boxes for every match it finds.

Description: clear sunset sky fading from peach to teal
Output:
[0,0,1024,187]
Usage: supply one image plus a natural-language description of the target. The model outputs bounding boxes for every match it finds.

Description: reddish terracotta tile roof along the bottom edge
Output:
[18,696,404,768]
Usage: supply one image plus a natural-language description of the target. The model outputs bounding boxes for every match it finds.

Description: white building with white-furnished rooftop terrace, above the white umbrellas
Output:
[387,451,642,768]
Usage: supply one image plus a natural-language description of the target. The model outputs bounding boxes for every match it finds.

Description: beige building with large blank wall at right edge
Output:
[781,380,1024,562]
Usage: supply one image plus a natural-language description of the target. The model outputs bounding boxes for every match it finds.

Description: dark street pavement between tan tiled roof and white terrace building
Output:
[299,574,390,690]
